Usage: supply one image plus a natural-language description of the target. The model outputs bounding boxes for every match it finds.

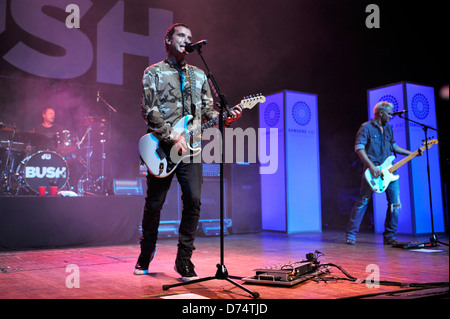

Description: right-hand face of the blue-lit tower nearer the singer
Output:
[285,91,322,233]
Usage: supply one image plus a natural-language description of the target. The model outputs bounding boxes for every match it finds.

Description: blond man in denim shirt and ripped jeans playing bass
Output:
[346,101,420,245]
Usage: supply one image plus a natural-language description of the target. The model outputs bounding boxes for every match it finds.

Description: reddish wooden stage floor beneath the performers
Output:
[0,231,449,302]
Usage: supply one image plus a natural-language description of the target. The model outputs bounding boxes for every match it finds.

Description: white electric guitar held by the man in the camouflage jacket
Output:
[139,94,266,177]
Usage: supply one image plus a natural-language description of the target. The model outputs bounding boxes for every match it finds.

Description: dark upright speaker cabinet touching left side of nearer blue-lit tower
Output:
[231,163,262,234]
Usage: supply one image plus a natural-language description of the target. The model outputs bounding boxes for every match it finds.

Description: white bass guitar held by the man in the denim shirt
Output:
[364,140,438,193]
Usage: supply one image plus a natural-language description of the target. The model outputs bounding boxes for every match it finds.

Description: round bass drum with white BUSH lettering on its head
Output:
[17,151,69,194]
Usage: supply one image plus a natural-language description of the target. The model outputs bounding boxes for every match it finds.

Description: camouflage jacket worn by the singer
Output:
[141,59,217,142]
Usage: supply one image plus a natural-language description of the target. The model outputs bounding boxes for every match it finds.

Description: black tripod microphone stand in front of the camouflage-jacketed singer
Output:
[163,44,259,298]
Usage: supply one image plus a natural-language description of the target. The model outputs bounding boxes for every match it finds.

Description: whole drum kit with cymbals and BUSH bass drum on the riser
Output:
[0,116,107,196]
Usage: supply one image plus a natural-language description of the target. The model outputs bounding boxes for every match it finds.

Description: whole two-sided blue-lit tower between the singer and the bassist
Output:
[259,91,322,233]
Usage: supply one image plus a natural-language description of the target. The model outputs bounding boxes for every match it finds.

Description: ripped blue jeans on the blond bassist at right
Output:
[347,176,401,240]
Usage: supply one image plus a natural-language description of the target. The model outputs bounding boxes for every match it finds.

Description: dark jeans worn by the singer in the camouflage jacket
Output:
[140,162,203,258]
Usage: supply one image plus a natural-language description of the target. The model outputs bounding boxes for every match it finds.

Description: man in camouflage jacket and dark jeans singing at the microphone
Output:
[134,23,241,281]
